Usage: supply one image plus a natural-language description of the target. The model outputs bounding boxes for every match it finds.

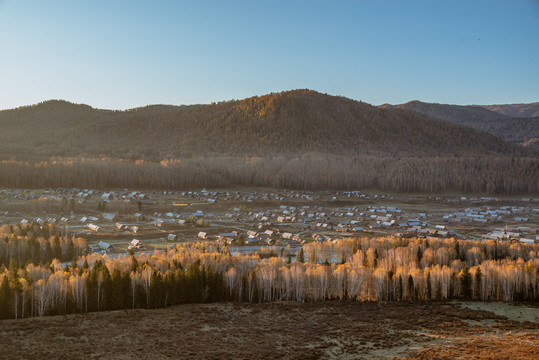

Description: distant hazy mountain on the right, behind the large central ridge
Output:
[381,101,539,151]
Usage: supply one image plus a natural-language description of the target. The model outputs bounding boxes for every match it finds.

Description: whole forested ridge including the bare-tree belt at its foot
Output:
[0,90,539,193]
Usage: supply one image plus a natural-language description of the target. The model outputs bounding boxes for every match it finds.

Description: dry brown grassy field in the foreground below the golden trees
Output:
[0,302,539,359]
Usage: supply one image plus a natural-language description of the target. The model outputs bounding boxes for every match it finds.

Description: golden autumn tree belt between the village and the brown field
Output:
[0,229,539,318]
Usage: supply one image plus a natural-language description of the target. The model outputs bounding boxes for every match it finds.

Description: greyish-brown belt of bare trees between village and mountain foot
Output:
[0,153,539,194]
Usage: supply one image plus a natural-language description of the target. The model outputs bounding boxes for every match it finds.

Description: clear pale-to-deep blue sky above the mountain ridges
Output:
[0,0,539,109]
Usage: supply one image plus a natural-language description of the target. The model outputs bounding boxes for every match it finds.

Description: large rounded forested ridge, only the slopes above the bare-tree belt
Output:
[0,90,521,160]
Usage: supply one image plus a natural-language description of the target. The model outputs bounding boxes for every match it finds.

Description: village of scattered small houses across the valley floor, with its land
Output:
[0,187,539,254]
